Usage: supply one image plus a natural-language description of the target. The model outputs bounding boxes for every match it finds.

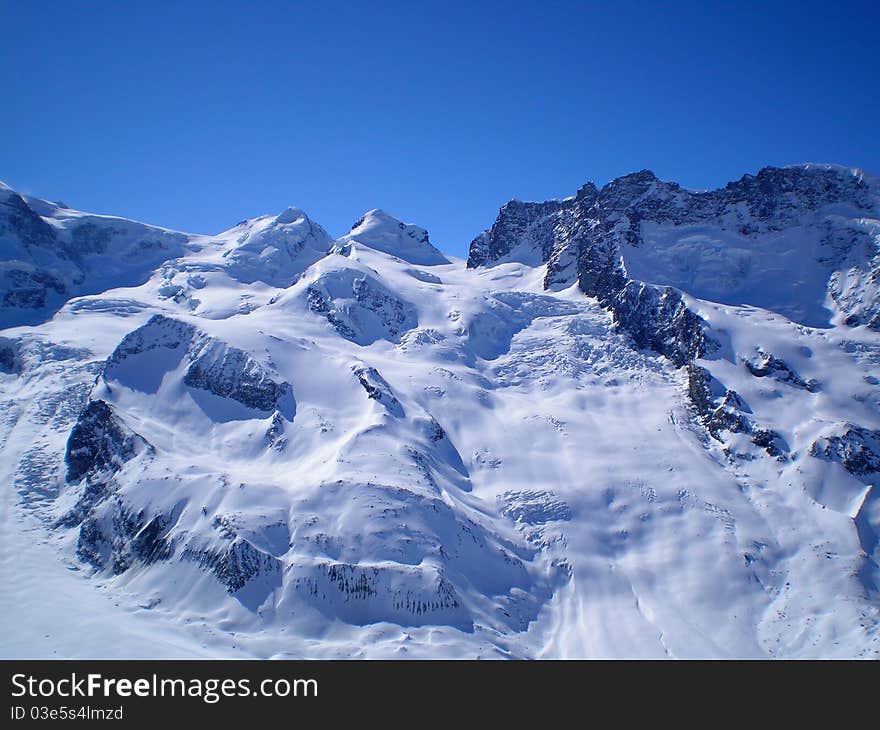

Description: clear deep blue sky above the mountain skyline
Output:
[0,0,880,255]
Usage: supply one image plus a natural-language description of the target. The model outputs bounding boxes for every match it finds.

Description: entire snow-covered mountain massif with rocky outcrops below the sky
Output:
[0,165,880,658]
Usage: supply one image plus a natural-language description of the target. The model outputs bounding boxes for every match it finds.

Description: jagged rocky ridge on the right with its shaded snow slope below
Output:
[468,165,880,332]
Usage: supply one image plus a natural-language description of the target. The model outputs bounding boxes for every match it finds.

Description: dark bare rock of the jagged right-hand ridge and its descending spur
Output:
[468,166,880,365]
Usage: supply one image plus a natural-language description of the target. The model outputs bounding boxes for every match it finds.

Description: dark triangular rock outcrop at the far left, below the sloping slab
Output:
[64,400,147,482]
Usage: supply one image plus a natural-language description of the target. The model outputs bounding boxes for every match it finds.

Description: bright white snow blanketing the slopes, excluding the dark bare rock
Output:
[0,179,880,658]
